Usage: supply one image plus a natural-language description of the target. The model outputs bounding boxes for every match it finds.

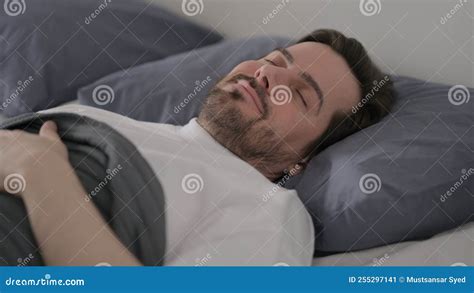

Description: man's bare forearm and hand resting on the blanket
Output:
[0,122,141,266]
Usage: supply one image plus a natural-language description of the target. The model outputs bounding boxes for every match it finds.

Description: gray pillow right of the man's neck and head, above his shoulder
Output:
[286,77,474,253]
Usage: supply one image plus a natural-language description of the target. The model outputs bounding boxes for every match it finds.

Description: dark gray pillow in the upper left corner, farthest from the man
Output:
[0,0,221,116]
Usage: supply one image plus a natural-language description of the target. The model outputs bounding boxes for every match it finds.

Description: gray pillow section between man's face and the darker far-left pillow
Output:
[78,36,289,125]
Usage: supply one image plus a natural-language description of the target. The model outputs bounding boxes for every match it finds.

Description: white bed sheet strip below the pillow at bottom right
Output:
[313,222,474,266]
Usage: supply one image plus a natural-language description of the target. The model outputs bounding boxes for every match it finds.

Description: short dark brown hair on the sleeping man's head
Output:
[297,29,394,157]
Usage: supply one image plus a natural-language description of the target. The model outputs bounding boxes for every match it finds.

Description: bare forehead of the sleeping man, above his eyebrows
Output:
[272,42,359,108]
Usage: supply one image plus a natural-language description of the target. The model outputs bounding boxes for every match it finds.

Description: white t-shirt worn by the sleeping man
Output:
[42,105,314,266]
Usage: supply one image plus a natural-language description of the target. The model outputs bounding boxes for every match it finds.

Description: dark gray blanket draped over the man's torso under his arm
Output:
[0,113,166,266]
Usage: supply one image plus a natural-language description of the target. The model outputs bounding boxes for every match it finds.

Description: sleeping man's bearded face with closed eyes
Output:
[198,42,360,178]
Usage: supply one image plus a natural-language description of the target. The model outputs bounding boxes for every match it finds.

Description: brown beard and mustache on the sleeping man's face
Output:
[198,74,295,177]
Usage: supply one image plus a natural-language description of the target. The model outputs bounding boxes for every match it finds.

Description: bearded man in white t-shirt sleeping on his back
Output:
[0,29,393,265]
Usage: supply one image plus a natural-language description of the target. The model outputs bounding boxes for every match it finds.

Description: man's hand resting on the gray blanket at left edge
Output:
[0,121,68,194]
